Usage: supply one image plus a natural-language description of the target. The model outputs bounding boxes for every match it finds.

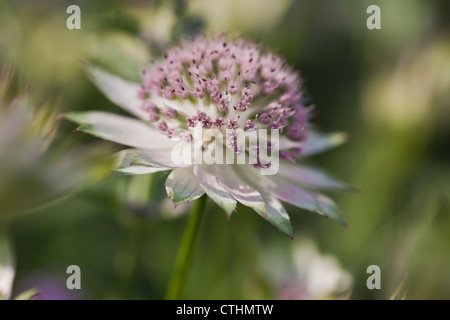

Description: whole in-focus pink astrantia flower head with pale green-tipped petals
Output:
[66,36,347,237]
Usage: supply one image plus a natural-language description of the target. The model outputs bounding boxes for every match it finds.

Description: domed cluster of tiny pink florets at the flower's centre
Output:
[135,36,309,158]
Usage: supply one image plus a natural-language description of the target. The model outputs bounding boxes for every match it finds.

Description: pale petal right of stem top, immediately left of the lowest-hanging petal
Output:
[216,165,267,215]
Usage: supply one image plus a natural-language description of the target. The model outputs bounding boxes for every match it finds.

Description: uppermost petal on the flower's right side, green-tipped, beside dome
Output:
[300,130,348,156]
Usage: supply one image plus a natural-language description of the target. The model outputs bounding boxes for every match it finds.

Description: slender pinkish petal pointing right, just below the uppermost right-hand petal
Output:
[278,162,352,190]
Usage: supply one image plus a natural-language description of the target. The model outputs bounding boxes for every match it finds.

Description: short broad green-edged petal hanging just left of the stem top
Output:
[166,167,205,206]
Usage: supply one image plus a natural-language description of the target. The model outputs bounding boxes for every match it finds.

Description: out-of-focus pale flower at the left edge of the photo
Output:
[0,66,110,217]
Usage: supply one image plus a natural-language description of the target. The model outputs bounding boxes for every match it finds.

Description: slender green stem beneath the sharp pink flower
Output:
[166,196,208,300]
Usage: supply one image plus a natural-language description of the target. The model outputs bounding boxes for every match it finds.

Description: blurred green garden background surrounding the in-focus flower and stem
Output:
[0,0,450,299]
